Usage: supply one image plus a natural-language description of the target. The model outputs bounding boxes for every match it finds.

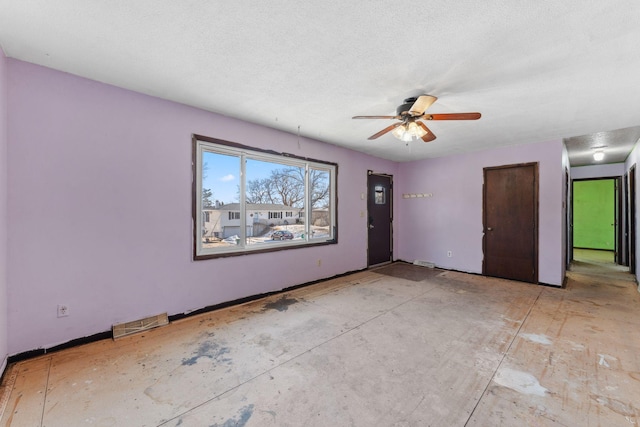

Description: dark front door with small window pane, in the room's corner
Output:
[367,171,393,266]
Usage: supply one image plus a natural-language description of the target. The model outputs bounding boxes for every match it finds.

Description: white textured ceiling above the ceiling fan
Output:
[0,0,640,161]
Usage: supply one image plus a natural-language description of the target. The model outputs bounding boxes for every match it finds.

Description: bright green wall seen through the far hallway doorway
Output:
[573,179,616,251]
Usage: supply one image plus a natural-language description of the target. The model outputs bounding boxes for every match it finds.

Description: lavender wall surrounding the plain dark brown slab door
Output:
[395,141,564,286]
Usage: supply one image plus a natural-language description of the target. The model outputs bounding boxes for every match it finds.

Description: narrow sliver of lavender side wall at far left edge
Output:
[0,47,8,372]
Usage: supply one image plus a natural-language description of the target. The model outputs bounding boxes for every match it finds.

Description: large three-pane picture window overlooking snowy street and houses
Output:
[193,135,337,259]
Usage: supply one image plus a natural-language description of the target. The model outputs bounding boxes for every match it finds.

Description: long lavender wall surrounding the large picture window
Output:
[5,59,397,354]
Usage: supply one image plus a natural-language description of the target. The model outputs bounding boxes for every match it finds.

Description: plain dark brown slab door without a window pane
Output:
[482,163,538,283]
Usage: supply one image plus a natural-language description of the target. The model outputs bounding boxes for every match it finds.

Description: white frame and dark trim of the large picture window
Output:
[191,134,338,261]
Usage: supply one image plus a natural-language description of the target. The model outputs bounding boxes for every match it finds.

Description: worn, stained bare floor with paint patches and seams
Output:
[0,264,640,427]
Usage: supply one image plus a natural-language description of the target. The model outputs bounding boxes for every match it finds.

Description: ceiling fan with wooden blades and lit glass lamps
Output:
[352,95,480,142]
